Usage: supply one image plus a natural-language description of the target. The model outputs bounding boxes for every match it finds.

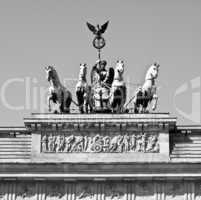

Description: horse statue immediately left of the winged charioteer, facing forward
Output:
[75,64,92,113]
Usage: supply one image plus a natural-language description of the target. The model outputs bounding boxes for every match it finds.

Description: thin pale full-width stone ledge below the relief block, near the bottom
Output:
[0,173,201,181]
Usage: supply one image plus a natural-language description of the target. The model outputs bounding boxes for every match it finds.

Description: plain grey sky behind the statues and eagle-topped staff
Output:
[0,0,201,126]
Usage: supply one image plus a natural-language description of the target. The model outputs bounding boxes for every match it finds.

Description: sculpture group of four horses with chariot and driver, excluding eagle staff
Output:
[45,60,159,113]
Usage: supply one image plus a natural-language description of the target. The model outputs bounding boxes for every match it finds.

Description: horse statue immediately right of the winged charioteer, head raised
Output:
[110,60,126,113]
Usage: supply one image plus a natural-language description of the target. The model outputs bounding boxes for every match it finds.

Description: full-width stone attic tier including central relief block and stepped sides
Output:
[0,113,201,163]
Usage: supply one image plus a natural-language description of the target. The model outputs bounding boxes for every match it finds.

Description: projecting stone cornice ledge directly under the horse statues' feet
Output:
[24,113,176,129]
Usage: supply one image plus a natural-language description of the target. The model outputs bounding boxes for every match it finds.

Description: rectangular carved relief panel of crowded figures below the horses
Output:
[41,133,160,153]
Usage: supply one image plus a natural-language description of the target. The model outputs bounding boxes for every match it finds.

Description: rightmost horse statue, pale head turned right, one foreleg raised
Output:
[134,63,160,113]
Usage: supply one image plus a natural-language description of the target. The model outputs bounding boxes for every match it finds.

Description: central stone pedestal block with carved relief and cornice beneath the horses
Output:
[24,113,176,163]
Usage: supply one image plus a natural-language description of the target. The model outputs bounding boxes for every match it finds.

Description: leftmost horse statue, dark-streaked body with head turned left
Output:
[45,66,72,113]
